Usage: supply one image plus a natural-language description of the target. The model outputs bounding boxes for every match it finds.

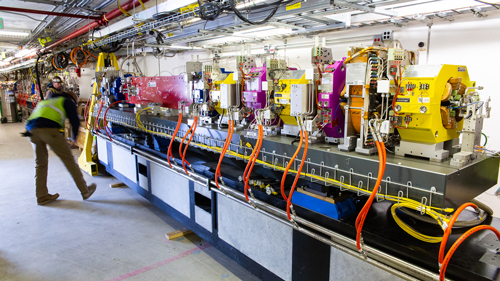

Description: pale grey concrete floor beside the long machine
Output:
[0,123,259,281]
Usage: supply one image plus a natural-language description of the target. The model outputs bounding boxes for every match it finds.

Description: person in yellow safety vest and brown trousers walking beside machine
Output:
[26,76,96,205]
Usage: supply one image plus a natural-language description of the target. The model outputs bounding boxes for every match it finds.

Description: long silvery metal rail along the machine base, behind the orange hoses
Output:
[97,133,451,281]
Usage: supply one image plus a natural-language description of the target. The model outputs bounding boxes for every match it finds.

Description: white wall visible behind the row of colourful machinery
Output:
[80,12,500,150]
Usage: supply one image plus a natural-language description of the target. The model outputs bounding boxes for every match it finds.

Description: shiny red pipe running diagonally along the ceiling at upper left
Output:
[12,0,149,63]
